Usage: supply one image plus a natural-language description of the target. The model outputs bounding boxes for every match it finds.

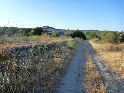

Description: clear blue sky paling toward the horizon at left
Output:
[0,0,124,31]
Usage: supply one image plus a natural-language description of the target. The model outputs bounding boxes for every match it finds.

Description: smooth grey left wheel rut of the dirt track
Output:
[59,41,86,93]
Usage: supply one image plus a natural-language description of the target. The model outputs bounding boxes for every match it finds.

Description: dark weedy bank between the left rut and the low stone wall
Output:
[0,40,80,93]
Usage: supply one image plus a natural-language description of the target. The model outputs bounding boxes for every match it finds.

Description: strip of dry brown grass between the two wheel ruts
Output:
[85,44,106,93]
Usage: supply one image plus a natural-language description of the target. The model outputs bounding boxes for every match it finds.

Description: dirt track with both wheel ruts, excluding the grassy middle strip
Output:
[59,41,124,93]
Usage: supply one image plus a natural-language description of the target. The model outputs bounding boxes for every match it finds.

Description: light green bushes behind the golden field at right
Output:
[87,31,124,43]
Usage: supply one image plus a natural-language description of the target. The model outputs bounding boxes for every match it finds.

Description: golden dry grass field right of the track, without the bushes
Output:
[90,41,124,78]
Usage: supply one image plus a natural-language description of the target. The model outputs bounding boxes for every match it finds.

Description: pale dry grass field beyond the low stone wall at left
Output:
[0,34,72,48]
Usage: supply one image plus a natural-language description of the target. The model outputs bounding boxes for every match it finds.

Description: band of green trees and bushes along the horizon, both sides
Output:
[0,27,124,43]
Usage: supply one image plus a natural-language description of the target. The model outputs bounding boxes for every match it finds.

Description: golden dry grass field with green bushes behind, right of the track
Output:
[91,32,124,78]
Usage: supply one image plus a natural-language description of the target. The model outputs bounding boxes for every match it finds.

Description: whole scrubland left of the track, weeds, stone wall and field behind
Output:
[0,34,80,93]
